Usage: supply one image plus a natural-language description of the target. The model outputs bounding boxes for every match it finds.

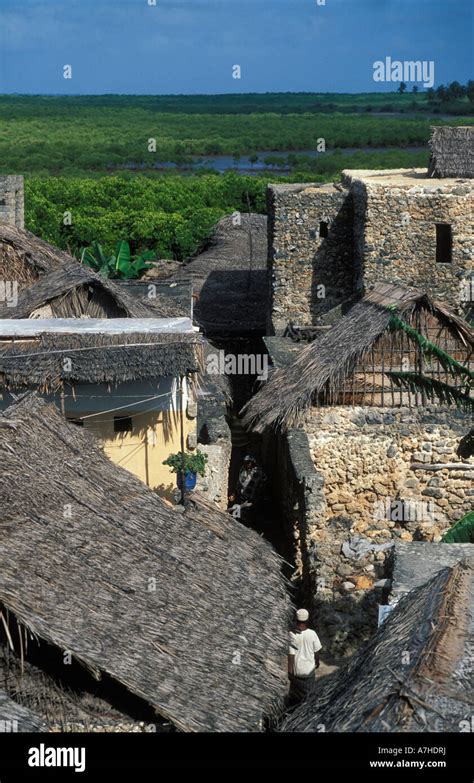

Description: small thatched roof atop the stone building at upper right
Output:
[428,125,474,178]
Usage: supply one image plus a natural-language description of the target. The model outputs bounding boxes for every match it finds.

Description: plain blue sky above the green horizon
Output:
[0,0,473,94]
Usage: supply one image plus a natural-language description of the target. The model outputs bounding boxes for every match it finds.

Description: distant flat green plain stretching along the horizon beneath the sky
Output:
[0,93,472,176]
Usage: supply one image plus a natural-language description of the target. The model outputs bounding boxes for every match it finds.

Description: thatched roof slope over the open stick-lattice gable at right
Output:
[243,283,474,432]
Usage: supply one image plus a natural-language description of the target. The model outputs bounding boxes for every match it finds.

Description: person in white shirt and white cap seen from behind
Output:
[288,609,322,706]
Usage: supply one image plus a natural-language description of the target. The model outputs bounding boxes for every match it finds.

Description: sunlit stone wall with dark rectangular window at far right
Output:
[343,172,474,310]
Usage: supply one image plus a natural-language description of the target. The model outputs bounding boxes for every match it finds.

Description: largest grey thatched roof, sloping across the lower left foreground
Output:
[0,394,290,731]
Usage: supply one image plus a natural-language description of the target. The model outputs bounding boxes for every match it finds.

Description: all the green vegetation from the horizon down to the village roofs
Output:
[0,88,474,263]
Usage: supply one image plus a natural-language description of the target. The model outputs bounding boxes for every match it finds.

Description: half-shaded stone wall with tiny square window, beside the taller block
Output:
[268,184,354,331]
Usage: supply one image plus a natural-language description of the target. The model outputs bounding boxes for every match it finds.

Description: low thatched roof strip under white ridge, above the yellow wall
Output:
[0,330,202,390]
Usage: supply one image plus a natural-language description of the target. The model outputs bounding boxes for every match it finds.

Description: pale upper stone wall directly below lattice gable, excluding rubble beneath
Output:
[308,406,474,541]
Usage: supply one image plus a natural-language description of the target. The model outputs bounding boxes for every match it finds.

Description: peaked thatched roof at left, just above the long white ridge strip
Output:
[0,258,184,319]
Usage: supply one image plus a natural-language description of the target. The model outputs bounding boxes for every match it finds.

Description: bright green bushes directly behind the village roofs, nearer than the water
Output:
[25,172,271,261]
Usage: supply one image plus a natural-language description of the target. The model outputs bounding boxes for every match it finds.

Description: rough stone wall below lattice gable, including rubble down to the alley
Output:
[305,407,474,655]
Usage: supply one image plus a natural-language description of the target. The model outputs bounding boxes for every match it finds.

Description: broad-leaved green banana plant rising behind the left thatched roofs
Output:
[81,239,155,280]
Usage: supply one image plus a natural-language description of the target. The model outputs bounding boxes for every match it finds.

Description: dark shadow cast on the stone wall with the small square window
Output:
[311,202,356,324]
